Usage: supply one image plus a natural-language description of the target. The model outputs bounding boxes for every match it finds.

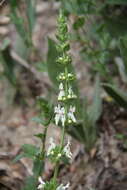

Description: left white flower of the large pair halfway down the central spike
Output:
[55,104,66,126]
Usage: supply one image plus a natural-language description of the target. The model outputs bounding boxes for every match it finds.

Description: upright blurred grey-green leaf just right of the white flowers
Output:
[89,76,102,125]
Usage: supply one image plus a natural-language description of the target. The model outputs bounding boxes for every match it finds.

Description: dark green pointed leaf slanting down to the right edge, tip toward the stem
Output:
[102,84,127,108]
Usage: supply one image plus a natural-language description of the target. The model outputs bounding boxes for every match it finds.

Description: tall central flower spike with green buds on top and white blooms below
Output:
[39,11,77,190]
